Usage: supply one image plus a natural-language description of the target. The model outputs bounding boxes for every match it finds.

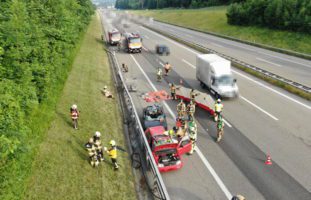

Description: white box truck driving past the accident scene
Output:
[196,54,239,98]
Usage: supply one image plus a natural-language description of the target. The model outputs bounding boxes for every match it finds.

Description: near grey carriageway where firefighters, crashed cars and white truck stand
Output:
[102,10,311,200]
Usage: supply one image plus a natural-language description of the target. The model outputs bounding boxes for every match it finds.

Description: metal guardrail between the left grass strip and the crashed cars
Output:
[110,52,170,200]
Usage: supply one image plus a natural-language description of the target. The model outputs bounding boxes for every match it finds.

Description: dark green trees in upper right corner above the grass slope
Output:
[227,0,311,33]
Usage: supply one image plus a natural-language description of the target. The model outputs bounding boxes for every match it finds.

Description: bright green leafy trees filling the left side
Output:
[0,0,94,166]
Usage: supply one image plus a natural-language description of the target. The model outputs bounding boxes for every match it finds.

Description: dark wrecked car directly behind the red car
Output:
[143,103,167,130]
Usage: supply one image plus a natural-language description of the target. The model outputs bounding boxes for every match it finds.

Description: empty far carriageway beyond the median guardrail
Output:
[144,21,311,87]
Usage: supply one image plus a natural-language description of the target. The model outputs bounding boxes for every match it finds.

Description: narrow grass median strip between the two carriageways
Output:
[148,26,311,101]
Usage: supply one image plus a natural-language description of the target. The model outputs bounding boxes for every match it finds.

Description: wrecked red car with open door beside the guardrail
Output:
[145,126,192,172]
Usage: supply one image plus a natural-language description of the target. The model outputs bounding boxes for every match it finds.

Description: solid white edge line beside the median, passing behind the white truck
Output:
[141,26,311,110]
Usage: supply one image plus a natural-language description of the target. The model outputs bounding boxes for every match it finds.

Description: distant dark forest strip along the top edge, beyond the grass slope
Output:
[115,0,244,9]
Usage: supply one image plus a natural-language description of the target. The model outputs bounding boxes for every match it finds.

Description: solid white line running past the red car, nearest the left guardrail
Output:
[131,55,232,199]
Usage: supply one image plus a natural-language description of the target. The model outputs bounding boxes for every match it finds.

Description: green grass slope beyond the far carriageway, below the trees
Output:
[131,6,311,54]
